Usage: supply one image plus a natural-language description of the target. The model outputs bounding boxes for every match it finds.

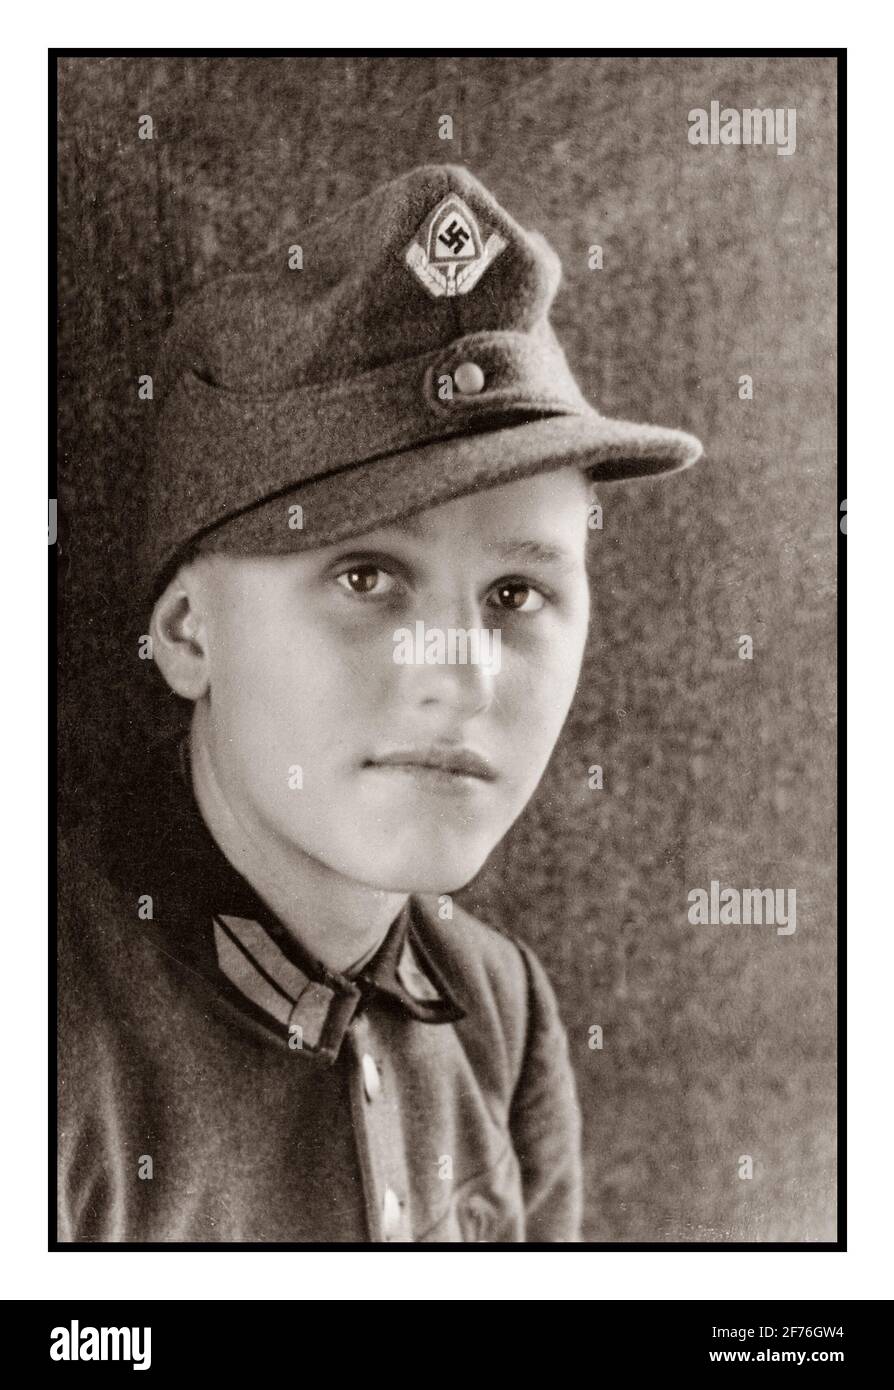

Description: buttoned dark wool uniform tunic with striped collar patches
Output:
[57,742,581,1244]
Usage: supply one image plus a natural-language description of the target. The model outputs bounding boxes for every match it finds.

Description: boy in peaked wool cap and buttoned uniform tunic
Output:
[58,165,701,1243]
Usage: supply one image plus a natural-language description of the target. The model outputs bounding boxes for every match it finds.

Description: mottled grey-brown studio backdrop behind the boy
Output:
[58,57,837,1241]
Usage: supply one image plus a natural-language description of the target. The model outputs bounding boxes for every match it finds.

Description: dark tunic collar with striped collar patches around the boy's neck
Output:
[117,734,466,1062]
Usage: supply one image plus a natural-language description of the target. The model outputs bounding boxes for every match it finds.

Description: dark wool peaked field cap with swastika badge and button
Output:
[142,164,702,592]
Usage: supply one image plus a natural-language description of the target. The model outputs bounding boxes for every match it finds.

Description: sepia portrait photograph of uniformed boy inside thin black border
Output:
[49,50,847,1251]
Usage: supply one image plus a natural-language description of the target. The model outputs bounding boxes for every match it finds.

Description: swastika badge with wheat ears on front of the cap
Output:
[406,193,506,299]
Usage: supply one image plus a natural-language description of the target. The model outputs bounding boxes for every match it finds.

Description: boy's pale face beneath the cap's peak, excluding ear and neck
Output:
[187,467,590,892]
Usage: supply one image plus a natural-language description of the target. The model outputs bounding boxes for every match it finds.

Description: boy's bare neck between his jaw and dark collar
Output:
[189,721,409,974]
